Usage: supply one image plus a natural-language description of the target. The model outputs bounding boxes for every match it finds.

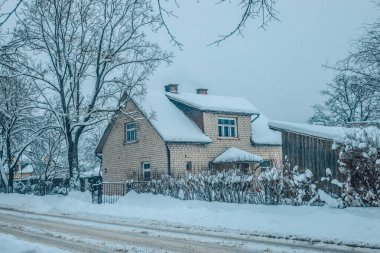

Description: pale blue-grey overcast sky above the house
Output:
[149,0,380,122]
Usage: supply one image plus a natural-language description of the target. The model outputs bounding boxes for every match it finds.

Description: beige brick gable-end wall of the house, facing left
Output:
[102,102,168,182]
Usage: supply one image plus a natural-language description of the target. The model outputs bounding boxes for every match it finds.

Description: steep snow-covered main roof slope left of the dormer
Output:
[135,90,211,143]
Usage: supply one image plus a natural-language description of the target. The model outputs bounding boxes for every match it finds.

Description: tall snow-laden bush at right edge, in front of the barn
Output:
[331,127,380,206]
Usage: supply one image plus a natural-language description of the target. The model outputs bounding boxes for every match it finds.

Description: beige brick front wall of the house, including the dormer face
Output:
[169,112,282,174]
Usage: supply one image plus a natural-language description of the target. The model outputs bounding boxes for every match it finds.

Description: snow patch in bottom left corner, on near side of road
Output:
[0,233,69,253]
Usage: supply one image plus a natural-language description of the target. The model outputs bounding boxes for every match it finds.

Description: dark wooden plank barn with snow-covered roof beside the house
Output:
[269,121,347,188]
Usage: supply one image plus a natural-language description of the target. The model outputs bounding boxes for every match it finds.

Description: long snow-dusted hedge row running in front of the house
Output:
[127,168,317,205]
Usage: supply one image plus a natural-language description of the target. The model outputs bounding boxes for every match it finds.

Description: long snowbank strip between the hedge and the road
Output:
[0,192,380,248]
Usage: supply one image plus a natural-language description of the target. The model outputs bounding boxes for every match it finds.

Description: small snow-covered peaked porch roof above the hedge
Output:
[213,147,263,163]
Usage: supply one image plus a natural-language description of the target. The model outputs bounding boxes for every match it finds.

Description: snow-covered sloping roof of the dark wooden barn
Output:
[269,121,349,140]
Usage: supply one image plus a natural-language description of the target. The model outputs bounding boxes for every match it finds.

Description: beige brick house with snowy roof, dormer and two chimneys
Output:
[96,84,282,182]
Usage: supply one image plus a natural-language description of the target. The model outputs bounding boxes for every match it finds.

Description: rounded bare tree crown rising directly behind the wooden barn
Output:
[310,74,380,126]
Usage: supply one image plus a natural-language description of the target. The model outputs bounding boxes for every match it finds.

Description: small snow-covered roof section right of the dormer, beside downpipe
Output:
[251,113,282,145]
